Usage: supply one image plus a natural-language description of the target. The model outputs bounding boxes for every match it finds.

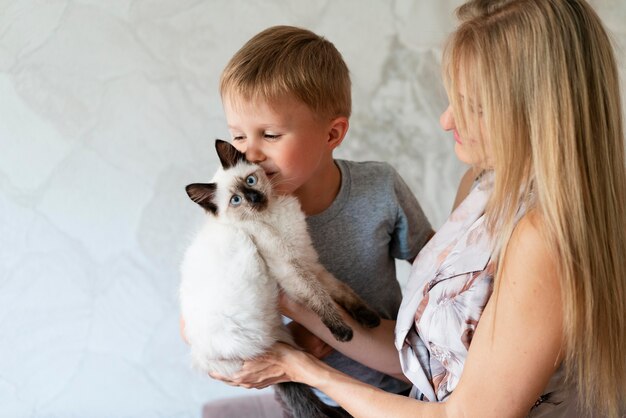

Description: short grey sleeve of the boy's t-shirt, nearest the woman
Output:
[390,170,432,260]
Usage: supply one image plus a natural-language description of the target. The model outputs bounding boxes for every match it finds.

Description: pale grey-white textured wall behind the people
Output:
[0,0,626,417]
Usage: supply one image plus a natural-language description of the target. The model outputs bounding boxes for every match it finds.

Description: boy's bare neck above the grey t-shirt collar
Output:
[294,159,341,216]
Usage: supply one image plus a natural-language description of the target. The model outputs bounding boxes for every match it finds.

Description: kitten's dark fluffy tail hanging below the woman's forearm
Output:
[274,382,345,418]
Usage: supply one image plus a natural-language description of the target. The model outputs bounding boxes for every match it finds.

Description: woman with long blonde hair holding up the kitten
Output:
[214,0,626,418]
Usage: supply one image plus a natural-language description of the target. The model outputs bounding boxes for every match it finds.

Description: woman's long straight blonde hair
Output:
[444,0,626,417]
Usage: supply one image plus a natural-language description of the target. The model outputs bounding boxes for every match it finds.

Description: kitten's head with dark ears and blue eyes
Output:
[186,140,272,220]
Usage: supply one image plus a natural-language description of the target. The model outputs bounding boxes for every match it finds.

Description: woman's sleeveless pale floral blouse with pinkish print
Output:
[395,172,578,417]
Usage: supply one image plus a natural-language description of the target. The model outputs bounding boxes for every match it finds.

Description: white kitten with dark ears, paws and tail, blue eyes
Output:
[180,140,380,418]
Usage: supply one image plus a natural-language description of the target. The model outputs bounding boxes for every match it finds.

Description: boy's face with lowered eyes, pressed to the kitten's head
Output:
[224,96,341,195]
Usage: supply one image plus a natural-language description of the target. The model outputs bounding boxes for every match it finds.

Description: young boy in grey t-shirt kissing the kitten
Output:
[204,26,432,417]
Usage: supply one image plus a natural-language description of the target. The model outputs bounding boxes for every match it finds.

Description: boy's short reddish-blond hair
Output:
[220,26,352,118]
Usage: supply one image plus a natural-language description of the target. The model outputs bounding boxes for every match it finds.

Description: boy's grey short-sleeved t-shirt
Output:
[307,160,432,405]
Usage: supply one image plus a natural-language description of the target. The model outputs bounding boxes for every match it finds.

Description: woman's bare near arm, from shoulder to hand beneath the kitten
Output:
[223,215,563,418]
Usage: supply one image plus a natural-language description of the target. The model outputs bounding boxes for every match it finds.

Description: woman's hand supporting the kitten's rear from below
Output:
[209,343,310,389]
